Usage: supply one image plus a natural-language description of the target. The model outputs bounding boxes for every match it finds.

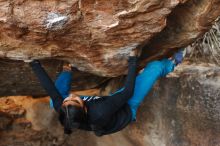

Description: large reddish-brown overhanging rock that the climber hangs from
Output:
[0,0,220,76]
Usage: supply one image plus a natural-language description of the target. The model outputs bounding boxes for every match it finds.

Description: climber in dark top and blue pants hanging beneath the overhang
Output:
[31,48,183,136]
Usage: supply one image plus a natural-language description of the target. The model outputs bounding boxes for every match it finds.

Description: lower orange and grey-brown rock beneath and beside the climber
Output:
[0,64,220,146]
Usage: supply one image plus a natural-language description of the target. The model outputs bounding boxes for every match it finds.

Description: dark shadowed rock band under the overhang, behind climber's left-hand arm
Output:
[0,59,108,97]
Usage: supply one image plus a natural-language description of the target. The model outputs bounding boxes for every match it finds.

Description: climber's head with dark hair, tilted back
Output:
[59,94,87,134]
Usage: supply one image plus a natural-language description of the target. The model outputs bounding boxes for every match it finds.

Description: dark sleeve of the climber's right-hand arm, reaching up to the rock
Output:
[90,57,137,126]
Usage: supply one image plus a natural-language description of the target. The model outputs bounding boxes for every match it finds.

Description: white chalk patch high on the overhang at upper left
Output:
[45,13,69,30]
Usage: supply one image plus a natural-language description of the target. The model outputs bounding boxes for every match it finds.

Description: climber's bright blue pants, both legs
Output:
[50,59,175,120]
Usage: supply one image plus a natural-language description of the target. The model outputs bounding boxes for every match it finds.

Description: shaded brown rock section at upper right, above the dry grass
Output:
[142,0,220,64]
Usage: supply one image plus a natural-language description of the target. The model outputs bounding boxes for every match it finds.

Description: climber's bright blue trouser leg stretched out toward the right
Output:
[128,59,175,120]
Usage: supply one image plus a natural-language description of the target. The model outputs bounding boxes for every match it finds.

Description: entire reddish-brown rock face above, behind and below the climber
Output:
[0,0,220,146]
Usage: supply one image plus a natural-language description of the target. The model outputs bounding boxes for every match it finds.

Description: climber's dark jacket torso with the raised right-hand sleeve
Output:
[79,57,137,136]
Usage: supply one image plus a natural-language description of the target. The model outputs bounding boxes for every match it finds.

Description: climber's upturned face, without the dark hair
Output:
[62,94,85,108]
